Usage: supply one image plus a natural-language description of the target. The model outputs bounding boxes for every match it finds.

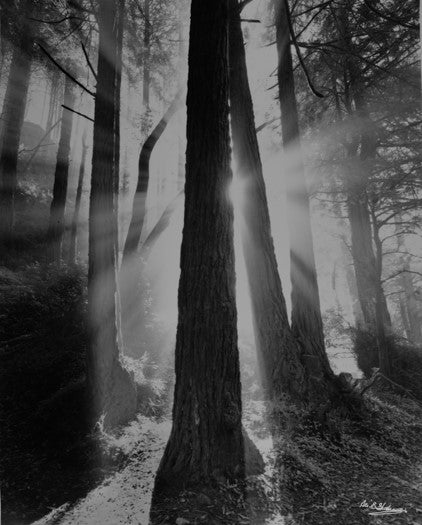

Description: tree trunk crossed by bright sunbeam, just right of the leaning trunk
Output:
[275,0,333,381]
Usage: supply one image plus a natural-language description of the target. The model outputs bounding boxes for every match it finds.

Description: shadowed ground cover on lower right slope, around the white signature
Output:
[275,390,422,525]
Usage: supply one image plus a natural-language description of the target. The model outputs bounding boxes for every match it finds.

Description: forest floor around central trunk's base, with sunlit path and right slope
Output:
[27,396,422,525]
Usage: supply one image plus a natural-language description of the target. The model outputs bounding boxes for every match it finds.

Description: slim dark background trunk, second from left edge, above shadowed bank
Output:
[47,73,75,262]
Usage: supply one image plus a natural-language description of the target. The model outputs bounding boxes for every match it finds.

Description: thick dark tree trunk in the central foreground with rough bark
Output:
[155,0,244,494]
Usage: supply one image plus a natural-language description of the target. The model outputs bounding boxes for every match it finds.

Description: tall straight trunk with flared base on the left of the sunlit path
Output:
[87,0,136,426]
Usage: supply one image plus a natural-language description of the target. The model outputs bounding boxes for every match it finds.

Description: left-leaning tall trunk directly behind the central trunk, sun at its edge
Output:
[229,0,306,397]
